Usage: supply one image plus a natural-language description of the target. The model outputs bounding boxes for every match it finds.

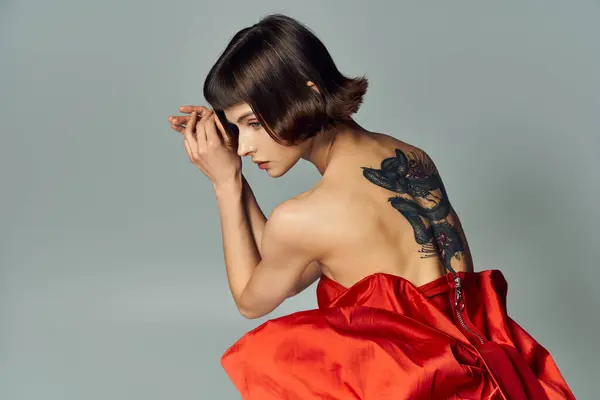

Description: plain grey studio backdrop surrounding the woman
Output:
[0,0,600,400]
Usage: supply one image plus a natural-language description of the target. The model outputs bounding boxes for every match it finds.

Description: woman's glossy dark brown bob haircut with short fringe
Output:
[204,14,368,146]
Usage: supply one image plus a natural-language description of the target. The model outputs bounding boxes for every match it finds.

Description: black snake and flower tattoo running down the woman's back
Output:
[361,149,464,273]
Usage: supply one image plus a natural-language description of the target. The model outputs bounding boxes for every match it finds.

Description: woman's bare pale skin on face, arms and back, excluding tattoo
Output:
[169,83,473,318]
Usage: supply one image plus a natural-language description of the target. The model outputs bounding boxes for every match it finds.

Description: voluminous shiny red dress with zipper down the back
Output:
[221,270,575,400]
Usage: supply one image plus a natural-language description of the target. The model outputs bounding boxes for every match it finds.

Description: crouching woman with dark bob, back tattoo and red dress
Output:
[170,15,573,400]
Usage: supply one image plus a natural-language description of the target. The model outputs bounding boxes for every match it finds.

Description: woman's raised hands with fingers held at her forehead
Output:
[169,106,242,189]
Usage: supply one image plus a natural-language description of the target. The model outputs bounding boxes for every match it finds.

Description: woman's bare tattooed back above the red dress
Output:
[299,132,473,287]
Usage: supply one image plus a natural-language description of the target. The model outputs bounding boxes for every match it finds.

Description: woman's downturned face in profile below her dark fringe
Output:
[223,103,311,178]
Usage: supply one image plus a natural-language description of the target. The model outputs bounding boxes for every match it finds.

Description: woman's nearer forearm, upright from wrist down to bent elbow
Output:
[215,176,264,305]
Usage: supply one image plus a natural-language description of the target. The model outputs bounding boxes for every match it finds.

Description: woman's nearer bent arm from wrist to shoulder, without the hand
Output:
[214,174,320,318]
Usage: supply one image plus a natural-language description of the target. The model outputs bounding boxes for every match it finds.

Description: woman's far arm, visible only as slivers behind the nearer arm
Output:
[242,175,321,297]
